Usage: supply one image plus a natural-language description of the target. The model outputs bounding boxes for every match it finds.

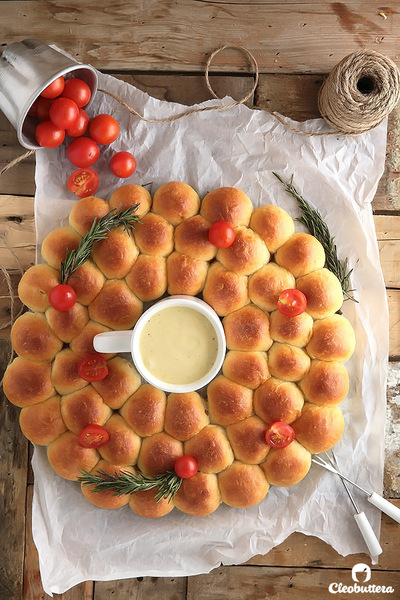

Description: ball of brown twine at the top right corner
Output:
[318,50,400,135]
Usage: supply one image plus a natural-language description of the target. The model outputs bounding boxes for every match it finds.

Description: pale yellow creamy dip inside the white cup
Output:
[139,306,218,385]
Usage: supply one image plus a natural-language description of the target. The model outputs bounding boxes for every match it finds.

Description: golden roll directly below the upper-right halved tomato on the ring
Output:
[269,310,314,348]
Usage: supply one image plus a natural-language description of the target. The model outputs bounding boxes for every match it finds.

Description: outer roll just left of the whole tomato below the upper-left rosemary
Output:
[18,264,60,312]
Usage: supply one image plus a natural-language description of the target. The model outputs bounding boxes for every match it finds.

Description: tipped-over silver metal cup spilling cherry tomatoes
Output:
[0,40,97,150]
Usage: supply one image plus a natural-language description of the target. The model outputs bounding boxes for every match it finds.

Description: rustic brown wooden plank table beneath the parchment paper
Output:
[0,0,400,600]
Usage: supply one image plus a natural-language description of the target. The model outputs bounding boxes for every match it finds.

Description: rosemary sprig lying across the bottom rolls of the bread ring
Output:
[77,469,182,502]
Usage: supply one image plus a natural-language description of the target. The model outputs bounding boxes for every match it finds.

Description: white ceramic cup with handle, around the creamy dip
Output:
[93,296,226,393]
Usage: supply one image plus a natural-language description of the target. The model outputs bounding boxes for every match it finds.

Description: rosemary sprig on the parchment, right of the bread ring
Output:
[273,172,358,303]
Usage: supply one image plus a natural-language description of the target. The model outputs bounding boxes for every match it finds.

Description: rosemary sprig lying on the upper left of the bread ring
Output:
[61,204,139,283]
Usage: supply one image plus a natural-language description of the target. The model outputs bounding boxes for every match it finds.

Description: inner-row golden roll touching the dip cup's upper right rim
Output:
[203,262,249,317]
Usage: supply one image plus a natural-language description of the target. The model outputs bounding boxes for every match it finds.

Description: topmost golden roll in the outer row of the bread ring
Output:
[153,181,200,225]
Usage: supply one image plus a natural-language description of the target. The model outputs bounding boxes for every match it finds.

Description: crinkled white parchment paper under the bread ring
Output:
[33,73,388,595]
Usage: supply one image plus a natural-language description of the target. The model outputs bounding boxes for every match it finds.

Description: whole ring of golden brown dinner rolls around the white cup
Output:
[3,181,355,518]
